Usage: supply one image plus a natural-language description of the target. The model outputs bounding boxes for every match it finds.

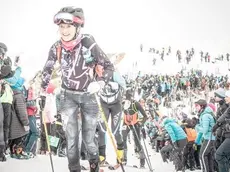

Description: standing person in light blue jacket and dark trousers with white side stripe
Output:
[195,99,215,172]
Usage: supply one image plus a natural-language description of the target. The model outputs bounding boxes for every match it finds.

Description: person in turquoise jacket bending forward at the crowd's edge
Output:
[163,118,187,172]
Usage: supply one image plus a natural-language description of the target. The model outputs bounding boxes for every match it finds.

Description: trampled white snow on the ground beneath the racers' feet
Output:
[0,132,199,172]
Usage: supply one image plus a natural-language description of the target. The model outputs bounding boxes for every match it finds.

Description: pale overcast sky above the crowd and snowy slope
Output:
[0,0,230,78]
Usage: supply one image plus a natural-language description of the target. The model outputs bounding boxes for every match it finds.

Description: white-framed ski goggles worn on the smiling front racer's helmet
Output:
[54,13,83,25]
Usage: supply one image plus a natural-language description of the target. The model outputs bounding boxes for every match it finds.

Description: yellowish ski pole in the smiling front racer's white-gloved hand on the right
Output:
[95,93,125,172]
